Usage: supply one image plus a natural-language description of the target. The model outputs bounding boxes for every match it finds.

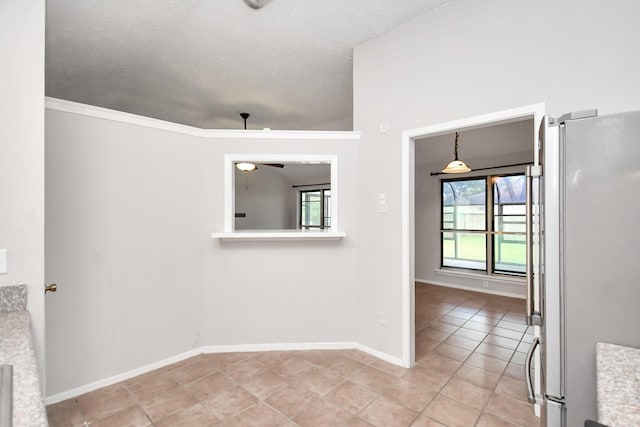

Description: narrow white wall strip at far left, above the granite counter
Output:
[0,0,45,384]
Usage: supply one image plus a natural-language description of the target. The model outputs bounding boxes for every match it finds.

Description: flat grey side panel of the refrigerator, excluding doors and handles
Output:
[561,112,640,426]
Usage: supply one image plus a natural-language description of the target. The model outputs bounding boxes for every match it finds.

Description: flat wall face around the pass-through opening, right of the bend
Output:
[201,140,360,345]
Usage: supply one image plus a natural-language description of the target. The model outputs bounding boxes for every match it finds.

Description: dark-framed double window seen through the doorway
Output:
[440,174,527,275]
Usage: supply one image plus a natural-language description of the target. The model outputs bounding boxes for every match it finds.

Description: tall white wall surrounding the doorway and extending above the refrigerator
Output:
[354,0,640,357]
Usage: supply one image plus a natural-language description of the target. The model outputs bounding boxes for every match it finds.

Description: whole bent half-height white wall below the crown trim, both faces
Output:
[46,108,358,396]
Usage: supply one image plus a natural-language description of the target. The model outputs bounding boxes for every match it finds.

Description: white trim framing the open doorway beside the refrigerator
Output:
[401,103,545,368]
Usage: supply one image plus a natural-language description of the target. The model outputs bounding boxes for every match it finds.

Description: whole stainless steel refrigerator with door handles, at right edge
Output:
[525,111,640,427]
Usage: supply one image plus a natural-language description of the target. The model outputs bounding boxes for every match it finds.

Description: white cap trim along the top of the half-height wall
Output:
[44,97,361,141]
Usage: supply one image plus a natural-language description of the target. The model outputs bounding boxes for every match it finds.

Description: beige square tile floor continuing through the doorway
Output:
[47,284,538,427]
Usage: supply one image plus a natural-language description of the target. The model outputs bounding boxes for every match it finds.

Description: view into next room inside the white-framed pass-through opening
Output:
[233,158,333,230]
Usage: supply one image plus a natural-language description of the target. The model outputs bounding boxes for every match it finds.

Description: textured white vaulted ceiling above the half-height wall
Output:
[46,0,449,130]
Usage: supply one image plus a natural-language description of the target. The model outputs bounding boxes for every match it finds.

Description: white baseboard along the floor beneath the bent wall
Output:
[44,342,403,405]
